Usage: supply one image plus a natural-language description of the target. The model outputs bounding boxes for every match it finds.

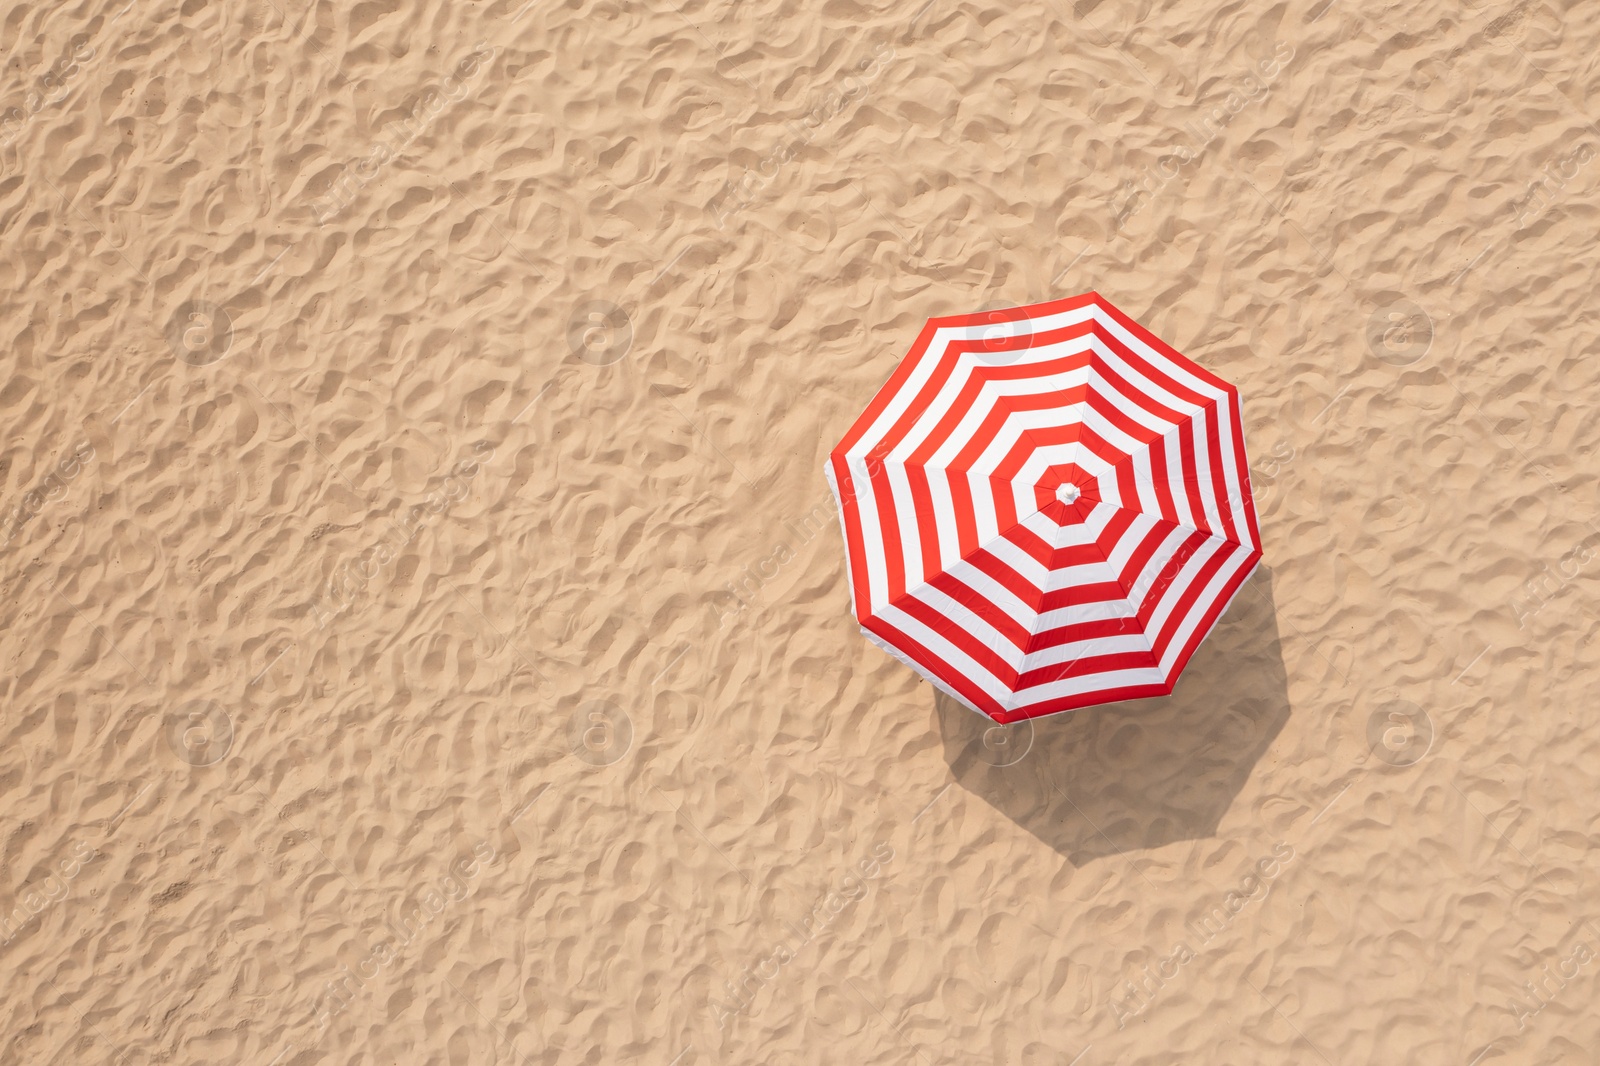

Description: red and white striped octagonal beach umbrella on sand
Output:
[827,293,1261,722]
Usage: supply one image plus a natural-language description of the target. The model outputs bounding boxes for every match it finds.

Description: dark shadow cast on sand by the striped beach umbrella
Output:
[934,567,1290,866]
